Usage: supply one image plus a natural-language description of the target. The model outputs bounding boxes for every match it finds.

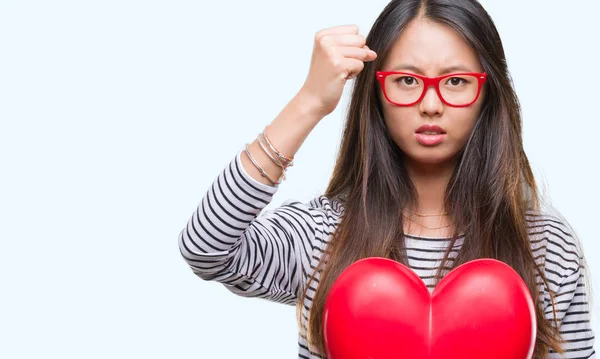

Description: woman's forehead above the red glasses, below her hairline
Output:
[383,19,482,76]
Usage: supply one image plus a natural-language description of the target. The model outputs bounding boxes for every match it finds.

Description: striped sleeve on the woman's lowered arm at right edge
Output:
[545,218,596,359]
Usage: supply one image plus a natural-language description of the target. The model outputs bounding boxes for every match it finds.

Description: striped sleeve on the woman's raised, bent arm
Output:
[178,151,317,305]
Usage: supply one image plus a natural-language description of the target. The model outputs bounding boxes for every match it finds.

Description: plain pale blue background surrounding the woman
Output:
[0,0,600,358]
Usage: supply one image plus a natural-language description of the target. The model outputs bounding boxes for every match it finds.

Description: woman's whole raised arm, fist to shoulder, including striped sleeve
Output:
[179,25,376,304]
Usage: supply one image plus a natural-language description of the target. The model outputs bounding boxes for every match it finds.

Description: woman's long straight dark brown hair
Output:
[298,0,562,359]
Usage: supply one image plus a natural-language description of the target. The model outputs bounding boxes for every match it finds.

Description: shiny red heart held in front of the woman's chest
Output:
[323,257,537,359]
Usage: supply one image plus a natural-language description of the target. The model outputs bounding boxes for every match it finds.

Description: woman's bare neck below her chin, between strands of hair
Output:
[406,160,454,214]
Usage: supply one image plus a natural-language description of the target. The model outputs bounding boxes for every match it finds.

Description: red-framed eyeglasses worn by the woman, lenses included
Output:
[376,71,487,107]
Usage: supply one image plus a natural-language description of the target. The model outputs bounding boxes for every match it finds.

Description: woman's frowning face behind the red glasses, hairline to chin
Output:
[379,19,485,165]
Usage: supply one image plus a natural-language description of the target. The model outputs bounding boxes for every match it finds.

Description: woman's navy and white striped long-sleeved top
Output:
[178,151,596,359]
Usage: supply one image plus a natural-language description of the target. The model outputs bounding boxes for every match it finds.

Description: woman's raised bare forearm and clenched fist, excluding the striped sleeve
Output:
[242,25,377,185]
